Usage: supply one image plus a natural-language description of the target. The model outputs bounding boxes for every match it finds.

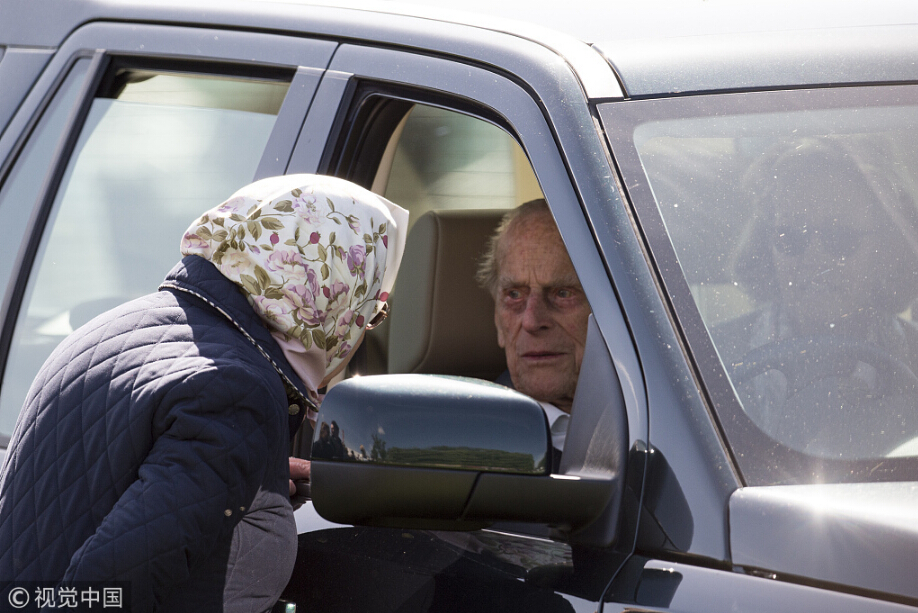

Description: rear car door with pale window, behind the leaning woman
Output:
[0,23,335,460]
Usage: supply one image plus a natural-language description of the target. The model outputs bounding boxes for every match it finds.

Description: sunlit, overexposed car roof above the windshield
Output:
[394,0,918,97]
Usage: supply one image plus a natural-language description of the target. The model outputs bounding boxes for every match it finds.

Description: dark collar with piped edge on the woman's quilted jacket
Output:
[159,255,316,410]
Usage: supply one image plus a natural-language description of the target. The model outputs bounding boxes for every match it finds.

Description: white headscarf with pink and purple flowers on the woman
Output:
[181,174,408,391]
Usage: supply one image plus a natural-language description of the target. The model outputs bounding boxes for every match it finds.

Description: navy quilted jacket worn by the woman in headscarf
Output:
[0,256,308,613]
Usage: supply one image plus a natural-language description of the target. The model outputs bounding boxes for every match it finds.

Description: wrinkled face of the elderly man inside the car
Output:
[494,213,590,412]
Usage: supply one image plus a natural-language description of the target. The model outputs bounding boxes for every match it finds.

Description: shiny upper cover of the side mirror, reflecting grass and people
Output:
[312,375,550,475]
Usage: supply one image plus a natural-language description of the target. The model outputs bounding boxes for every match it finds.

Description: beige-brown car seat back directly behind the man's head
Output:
[388,210,507,380]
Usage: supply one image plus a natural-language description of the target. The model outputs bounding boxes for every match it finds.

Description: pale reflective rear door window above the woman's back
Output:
[0,68,289,435]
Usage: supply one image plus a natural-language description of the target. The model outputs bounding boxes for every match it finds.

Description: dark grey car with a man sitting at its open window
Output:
[0,0,918,613]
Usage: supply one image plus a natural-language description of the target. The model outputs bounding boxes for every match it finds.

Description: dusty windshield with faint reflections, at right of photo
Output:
[603,87,918,483]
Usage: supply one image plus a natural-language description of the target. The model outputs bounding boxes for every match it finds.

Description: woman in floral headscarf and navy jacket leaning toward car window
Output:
[0,175,407,613]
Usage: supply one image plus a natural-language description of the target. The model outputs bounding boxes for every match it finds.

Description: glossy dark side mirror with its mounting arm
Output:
[312,375,620,531]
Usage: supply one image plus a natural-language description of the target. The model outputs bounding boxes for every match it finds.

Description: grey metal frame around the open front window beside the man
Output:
[288,34,647,604]
